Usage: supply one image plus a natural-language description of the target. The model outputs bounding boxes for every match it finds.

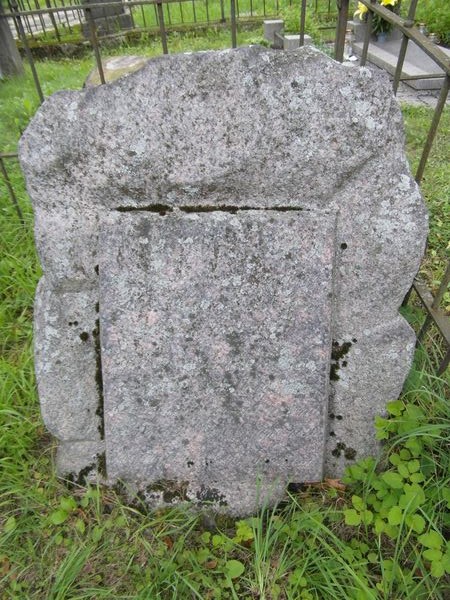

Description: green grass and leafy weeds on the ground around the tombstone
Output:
[0,32,450,600]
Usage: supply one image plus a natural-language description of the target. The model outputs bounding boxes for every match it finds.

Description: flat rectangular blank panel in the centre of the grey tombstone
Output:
[100,210,335,511]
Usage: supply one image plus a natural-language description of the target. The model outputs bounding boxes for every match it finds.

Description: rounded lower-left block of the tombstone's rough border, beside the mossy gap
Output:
[34,277,102,442]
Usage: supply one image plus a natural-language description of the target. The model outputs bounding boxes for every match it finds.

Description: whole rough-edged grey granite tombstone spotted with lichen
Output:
[20,47,427,514]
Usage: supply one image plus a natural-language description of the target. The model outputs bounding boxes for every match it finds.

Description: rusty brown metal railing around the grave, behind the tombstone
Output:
[0,0,450,374]
